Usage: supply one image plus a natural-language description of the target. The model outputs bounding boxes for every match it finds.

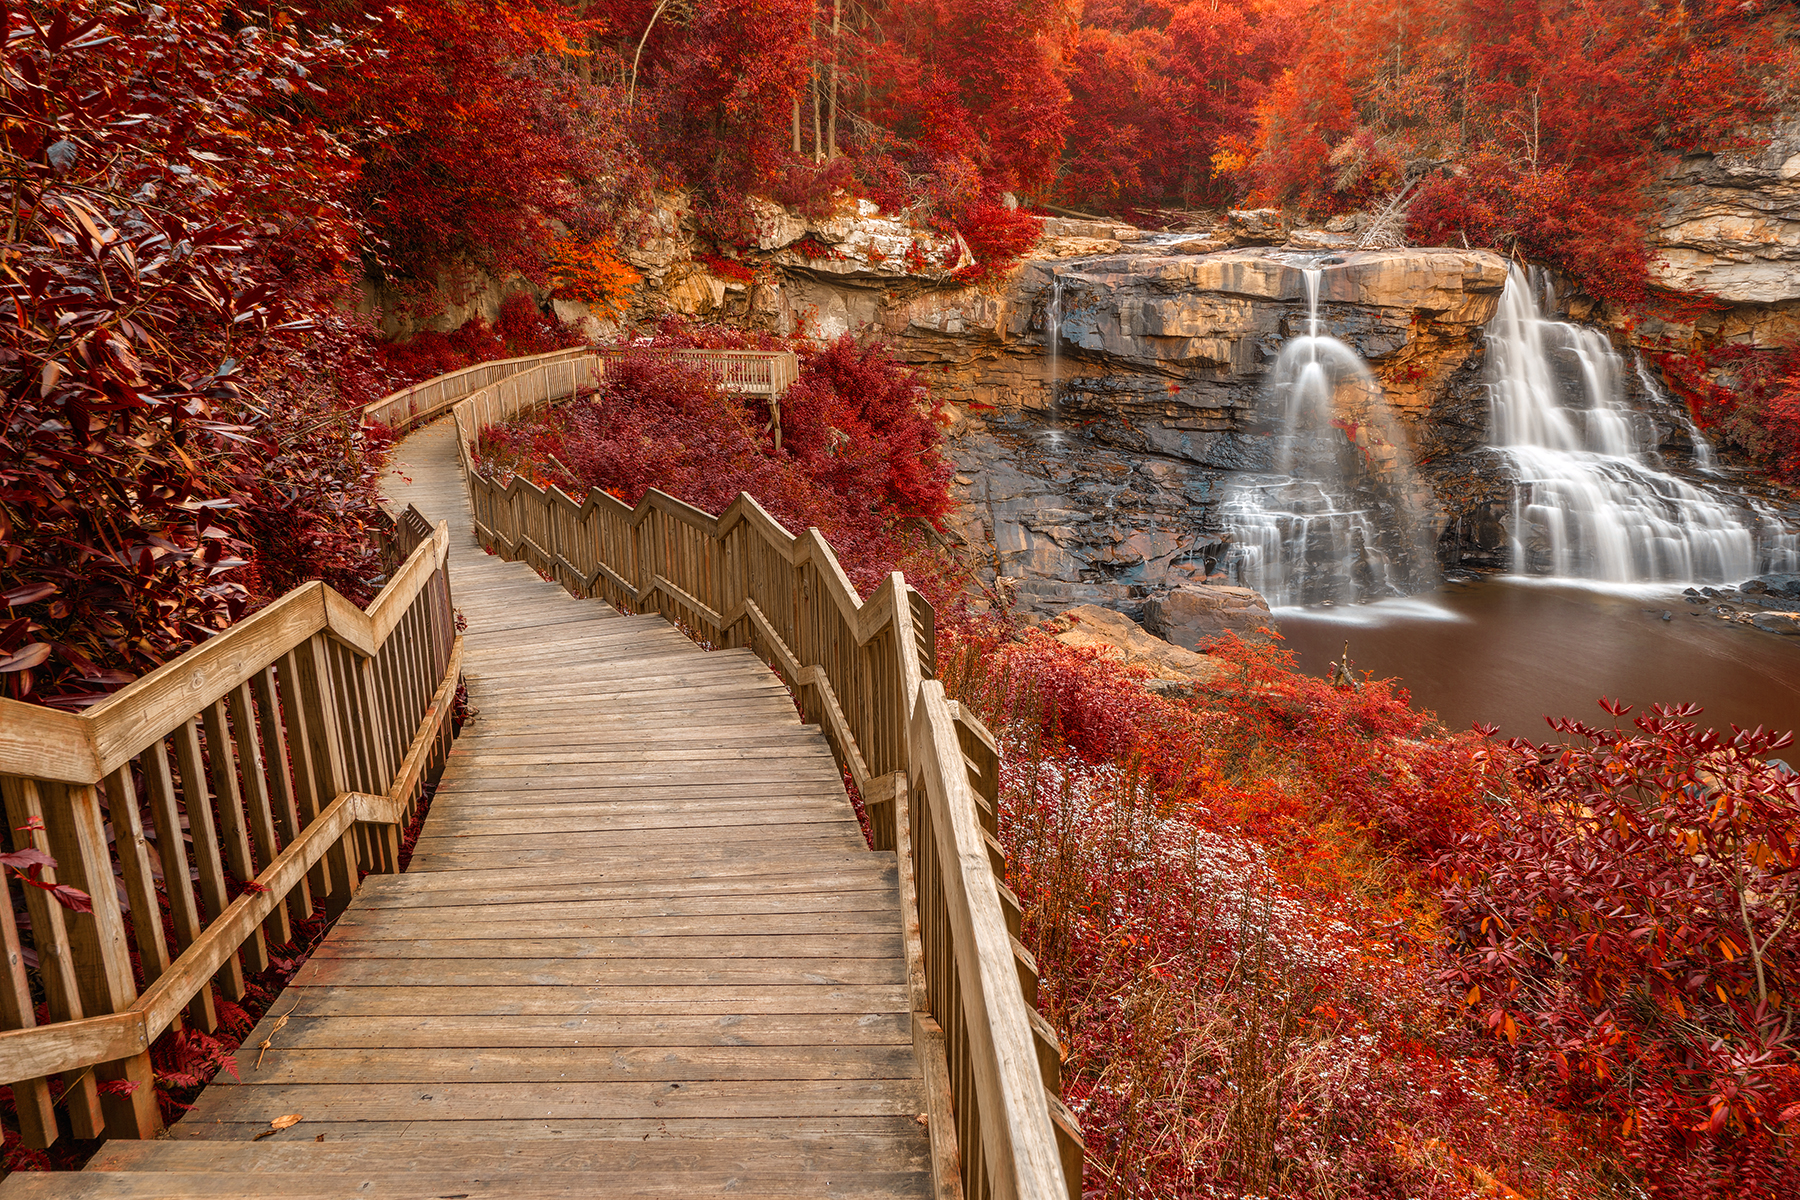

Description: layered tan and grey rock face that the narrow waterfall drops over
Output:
[900,248,1507,613]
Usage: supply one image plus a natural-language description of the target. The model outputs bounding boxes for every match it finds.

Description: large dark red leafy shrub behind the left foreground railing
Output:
[0,2,396,705]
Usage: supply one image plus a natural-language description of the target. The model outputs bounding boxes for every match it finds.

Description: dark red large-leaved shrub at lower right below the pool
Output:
[1435,705,1800,1198]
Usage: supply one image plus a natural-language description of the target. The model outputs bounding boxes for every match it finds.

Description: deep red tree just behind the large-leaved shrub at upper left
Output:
[325,0,646,302]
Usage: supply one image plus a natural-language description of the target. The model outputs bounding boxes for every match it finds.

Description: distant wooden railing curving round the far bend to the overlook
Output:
[362,347,799,434]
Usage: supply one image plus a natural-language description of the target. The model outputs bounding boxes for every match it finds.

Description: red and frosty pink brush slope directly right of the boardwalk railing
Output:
[940,622,1609,1200]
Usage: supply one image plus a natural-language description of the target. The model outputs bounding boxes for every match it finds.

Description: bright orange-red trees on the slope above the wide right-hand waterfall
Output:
[1253,0,1795,300]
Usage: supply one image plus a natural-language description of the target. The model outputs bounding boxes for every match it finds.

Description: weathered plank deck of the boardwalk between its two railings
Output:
[10,421,932,1200]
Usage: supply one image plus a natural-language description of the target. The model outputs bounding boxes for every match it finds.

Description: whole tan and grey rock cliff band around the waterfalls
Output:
[365,177,1800,619]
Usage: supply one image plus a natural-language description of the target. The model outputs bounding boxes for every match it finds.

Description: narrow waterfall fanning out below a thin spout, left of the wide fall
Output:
[1224,266,1435,606]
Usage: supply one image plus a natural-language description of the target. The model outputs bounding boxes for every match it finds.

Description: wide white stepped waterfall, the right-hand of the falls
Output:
[1487,266,1778,583]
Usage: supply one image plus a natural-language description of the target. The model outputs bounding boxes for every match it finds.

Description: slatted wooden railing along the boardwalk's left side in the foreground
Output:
[0,509,463,1148]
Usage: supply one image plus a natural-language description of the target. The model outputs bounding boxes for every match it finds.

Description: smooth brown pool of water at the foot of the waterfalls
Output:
[1274,578,1800,741]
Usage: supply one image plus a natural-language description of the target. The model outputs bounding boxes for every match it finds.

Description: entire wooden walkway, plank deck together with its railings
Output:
[0,351,1082,1200]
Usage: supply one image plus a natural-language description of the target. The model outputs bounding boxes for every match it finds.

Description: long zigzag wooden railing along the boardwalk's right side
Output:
[454,352,1082,1200]
